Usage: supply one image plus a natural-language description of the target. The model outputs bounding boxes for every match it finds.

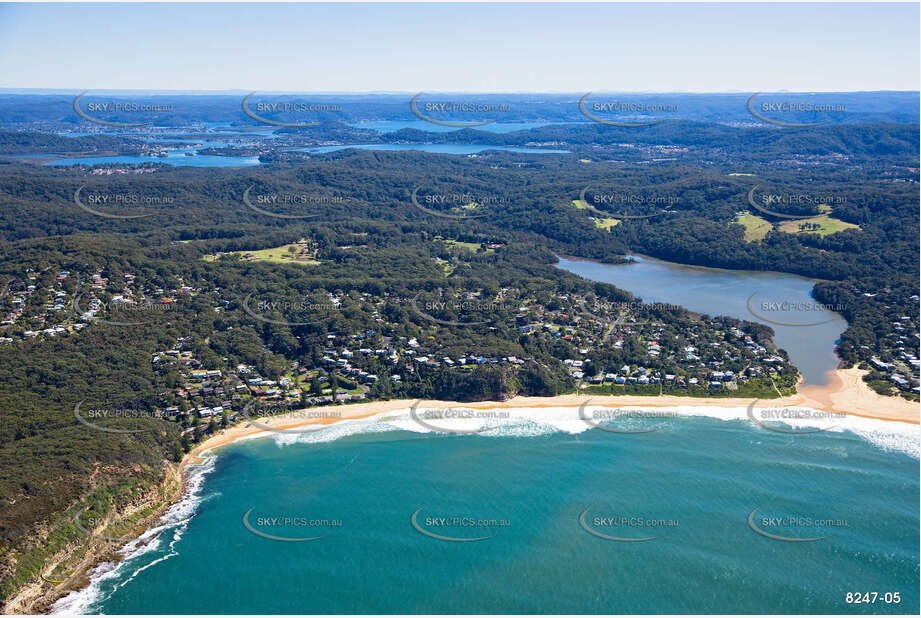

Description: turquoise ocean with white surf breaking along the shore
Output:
[55,408,919,614]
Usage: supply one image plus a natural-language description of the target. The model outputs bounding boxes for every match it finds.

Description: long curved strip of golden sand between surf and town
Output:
[183,367,921,465]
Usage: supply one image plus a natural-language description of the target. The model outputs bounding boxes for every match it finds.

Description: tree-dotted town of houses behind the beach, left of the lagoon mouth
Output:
[0,268,856,442]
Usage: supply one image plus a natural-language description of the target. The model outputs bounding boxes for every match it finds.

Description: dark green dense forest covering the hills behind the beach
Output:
[0,108,919,597]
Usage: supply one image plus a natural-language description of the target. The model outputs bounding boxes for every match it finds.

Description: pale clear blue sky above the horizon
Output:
[0,3,919,92]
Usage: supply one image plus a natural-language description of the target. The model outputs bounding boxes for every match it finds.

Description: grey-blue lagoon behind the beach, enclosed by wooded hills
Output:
[557,256,847,385]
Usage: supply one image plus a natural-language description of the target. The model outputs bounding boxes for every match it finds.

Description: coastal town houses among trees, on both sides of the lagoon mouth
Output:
[7,258,921,410]
